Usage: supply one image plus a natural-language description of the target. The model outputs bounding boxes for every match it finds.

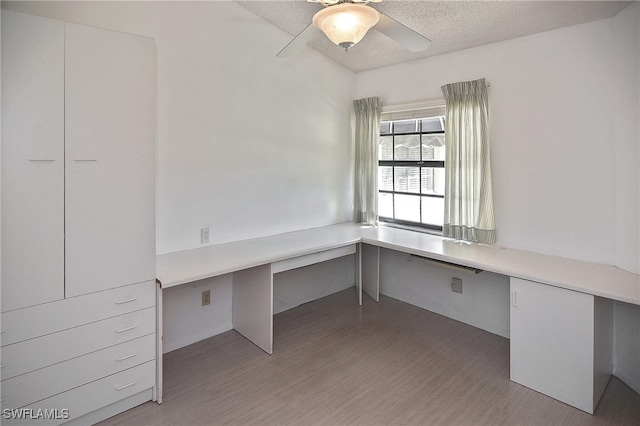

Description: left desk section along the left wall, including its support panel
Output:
[156,223,360,354]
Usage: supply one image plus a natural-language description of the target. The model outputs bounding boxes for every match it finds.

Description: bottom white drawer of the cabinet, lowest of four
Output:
[2,361,155,425]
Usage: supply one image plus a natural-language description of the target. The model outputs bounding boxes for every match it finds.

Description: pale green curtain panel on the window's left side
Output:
[353,97,380,225]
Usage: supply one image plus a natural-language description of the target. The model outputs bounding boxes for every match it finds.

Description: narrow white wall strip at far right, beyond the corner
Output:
[611,2,640,393]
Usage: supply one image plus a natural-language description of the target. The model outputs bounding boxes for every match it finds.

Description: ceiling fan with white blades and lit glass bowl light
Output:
[276,0,431,58]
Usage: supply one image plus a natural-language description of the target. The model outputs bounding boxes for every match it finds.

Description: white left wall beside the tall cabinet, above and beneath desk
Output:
[3,1,355,351]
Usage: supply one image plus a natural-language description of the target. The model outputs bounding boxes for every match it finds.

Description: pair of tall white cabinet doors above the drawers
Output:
[2,11,155,312]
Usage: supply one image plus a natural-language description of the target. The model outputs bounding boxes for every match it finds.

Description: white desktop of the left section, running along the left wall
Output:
[156,222,361,288]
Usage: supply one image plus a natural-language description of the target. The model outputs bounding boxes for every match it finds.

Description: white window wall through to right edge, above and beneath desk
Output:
[356,3,640,392]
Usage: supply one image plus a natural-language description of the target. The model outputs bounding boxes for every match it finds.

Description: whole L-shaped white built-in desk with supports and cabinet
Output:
[156,223,640,413]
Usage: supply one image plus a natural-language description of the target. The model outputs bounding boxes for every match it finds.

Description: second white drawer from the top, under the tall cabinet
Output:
[0,308,156,380]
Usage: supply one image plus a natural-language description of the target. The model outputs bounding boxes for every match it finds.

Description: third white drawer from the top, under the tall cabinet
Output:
[2,334,156,409]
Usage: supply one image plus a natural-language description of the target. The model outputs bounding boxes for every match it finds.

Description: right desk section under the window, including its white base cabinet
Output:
[361,227,640,414]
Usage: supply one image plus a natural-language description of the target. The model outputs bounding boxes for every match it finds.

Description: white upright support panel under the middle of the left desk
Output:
[232,264,273,354]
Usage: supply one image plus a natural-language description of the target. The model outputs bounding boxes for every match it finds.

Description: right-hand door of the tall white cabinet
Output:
[65,23,155,297]
